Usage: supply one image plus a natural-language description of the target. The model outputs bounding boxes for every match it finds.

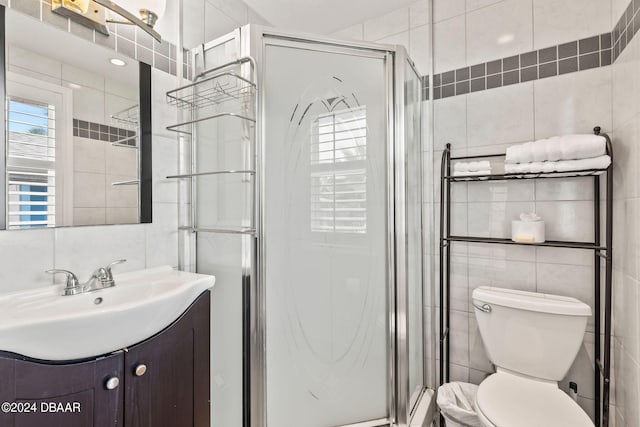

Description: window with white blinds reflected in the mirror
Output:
[6,97,56,229]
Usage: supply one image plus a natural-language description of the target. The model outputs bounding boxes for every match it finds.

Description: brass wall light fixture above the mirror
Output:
[51,0,167,42]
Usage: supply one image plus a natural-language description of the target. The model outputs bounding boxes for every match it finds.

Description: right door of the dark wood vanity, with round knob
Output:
[125,291,210,427]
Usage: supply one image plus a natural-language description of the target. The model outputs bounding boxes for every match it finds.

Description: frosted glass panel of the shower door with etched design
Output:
[264,45,389,427]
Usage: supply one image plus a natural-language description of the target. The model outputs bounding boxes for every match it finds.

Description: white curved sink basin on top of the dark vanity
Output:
[0,266,215,360]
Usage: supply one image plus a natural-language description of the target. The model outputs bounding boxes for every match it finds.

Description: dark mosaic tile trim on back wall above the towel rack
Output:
[433,33,612,99]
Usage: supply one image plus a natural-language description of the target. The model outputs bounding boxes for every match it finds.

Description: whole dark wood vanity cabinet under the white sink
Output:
[0,291,210,427]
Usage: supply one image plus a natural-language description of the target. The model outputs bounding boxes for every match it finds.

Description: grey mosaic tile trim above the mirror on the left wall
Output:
[7,0,177,76]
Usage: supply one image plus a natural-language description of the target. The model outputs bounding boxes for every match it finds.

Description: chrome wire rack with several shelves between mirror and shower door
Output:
[166,56,258,236]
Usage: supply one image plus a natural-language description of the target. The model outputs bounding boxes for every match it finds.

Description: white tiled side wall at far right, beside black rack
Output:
[611,4,640,427]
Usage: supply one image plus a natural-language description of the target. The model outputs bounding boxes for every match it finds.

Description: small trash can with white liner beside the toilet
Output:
[437,382,482,427]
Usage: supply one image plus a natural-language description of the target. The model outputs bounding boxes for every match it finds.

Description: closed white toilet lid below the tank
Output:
[476,372,593,427]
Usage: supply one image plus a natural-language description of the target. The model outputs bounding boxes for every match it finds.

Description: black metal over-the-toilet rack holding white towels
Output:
[439,127,613,427]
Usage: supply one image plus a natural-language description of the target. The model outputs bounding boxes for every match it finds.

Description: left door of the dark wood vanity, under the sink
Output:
[0,353,124,427]
